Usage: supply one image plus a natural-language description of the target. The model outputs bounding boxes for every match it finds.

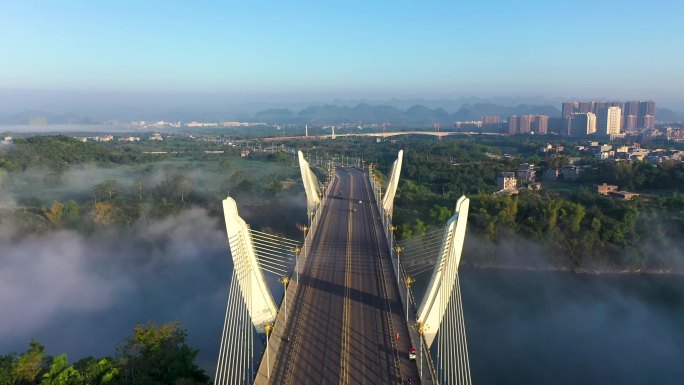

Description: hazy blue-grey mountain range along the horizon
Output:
[0,100,684,126]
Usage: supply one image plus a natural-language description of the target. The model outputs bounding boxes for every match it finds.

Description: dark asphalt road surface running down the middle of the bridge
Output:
[271,168,419,385]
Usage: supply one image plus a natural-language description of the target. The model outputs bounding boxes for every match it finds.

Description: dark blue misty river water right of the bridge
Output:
[461,269,684,385]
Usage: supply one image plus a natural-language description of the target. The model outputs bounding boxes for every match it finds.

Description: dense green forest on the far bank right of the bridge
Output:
[288,136,684,272]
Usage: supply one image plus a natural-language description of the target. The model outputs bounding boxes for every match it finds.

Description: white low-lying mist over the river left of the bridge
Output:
[0,208,231,367]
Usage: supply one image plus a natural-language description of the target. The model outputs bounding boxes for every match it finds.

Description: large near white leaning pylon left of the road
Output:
[223,197,278,333]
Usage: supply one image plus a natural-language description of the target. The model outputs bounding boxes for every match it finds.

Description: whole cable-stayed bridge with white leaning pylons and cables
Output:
[215,151,471,385]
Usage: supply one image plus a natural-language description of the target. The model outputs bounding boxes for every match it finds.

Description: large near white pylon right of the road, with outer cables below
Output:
[417,196,470,376]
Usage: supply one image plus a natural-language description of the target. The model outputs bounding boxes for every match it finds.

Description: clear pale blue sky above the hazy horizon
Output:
[0,0,684,104]
